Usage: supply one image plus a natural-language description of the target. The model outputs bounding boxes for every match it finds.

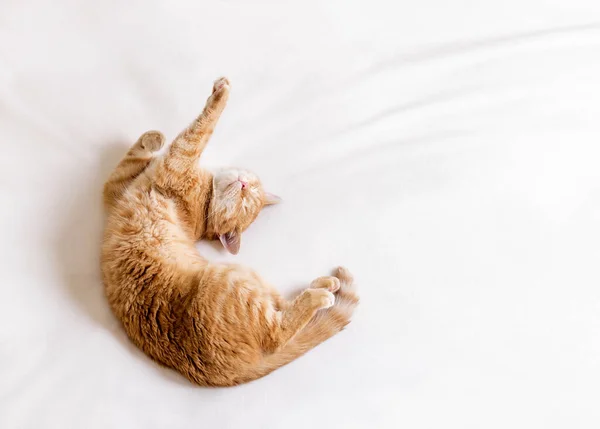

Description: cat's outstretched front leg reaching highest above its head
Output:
[165,77,230,172]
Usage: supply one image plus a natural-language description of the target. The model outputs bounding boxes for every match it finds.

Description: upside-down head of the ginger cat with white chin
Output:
[207,168,281,255]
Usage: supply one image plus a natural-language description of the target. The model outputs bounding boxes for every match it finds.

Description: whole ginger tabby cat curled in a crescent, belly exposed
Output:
[101,78,358,386]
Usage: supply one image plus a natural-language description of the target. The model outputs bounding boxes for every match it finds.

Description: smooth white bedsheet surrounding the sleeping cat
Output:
[0,0,600,429]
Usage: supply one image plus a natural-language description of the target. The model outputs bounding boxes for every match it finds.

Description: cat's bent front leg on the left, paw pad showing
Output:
[104,131,165,207]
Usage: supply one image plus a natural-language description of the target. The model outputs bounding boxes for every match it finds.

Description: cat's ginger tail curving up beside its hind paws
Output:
[241,267,359,381]
